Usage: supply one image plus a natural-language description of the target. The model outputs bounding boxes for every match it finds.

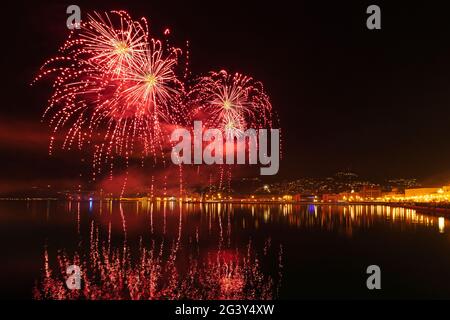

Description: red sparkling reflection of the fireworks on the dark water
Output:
[33,205,282,300]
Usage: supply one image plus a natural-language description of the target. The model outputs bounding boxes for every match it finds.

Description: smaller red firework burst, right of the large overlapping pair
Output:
[188,70,272,136]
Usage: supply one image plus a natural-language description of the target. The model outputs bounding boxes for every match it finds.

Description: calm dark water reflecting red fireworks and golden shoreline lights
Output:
[0,201,450,299]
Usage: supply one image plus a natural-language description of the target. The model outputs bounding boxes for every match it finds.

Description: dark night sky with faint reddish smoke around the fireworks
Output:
[0,0,450,190]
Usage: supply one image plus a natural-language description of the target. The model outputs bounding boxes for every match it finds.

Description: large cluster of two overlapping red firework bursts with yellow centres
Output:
[35,11,183,175]
